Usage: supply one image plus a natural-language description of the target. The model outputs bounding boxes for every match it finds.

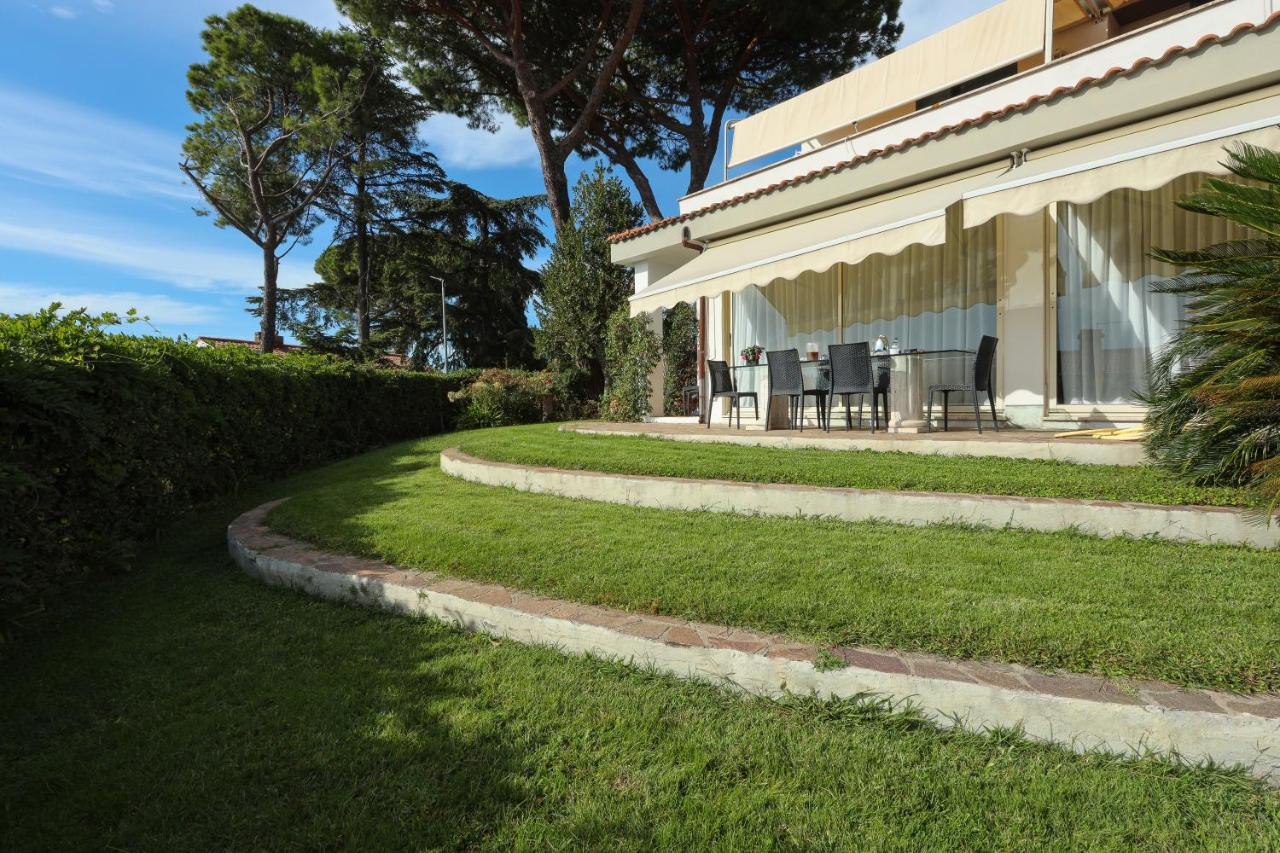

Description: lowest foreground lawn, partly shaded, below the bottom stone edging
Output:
[0,444,1280,853]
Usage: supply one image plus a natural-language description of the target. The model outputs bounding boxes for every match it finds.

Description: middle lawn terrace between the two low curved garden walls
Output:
[259,430,1280,692]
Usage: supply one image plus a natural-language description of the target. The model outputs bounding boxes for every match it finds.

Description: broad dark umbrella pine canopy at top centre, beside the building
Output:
[339,0,902,222]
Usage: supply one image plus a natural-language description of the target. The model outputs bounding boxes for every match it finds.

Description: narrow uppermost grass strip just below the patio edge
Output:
[458,424,1248,506]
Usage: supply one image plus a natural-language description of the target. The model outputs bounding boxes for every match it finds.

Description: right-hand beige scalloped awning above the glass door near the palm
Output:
[964,95,1280,228]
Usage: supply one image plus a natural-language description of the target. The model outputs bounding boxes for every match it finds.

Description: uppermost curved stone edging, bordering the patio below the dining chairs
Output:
[559,423,1147,466]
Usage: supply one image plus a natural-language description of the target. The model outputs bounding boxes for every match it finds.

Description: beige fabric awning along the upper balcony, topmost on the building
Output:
[730,0,1046,165]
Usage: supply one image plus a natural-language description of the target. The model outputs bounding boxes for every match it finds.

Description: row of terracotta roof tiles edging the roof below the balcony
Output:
[609,12,1280,243]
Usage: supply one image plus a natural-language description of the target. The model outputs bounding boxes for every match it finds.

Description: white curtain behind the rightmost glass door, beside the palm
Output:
[1057,174,1244,405]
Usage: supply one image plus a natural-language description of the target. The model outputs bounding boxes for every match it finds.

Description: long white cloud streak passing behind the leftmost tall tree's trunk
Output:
[0,220,315,293]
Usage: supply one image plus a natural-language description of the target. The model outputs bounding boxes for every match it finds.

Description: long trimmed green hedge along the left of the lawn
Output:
[0,310,474,635]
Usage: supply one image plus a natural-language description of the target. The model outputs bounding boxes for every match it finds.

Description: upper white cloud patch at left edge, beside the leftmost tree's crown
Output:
[0,83,195,201]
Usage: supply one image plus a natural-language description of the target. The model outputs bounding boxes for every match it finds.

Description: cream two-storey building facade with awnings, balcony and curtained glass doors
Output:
[612,0,1280,430]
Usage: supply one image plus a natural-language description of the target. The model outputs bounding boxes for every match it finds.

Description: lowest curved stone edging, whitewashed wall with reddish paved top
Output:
[227,501,1280,783]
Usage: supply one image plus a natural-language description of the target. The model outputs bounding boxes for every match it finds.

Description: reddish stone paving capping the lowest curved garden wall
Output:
[228,501,1280,719]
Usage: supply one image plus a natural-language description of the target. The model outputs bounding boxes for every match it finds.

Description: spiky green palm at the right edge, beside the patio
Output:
[1146,145,1280,517]
